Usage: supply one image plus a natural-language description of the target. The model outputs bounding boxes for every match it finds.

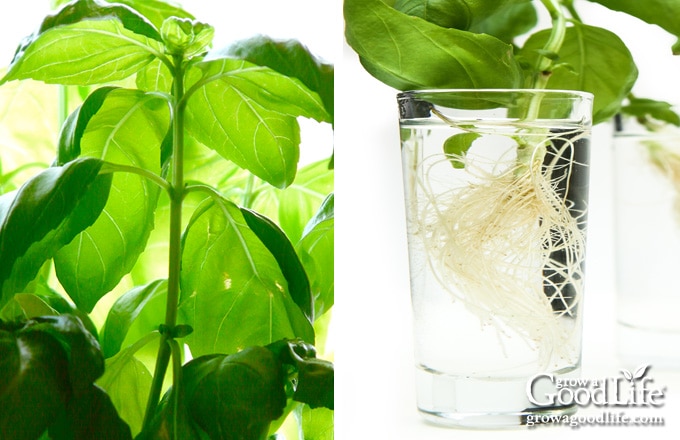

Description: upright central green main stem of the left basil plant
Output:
[144,55,185,428]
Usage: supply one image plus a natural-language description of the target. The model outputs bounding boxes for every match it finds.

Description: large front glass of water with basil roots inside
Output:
[398,90,592,428]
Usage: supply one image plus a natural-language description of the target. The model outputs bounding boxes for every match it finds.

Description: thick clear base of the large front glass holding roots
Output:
[416,367,578,429]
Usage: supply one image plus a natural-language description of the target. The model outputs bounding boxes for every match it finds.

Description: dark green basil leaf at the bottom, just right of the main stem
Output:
[142,347,286,440]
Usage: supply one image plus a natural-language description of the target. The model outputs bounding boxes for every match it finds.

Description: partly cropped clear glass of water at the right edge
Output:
[614,114,680,367]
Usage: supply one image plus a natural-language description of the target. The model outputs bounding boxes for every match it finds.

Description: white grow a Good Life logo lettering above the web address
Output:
[526,365,666,407]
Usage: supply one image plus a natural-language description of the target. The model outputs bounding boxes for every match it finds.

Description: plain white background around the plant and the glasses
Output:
[0,0,680,440]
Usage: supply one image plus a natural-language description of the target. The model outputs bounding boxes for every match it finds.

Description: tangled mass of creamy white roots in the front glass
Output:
[413,133,585,367]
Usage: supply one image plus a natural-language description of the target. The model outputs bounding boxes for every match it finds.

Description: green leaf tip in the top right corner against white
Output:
[589,0,680,42]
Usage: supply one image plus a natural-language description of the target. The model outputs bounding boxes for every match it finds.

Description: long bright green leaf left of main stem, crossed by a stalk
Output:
[55,89,170,312]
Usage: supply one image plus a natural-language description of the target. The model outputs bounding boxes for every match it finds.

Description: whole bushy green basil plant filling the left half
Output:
[0,0,334,440]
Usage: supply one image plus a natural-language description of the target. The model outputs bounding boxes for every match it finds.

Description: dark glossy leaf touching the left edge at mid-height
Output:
[0,159,111,307]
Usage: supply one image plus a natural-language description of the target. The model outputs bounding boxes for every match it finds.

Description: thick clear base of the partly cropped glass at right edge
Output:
[617,322,680,368]
